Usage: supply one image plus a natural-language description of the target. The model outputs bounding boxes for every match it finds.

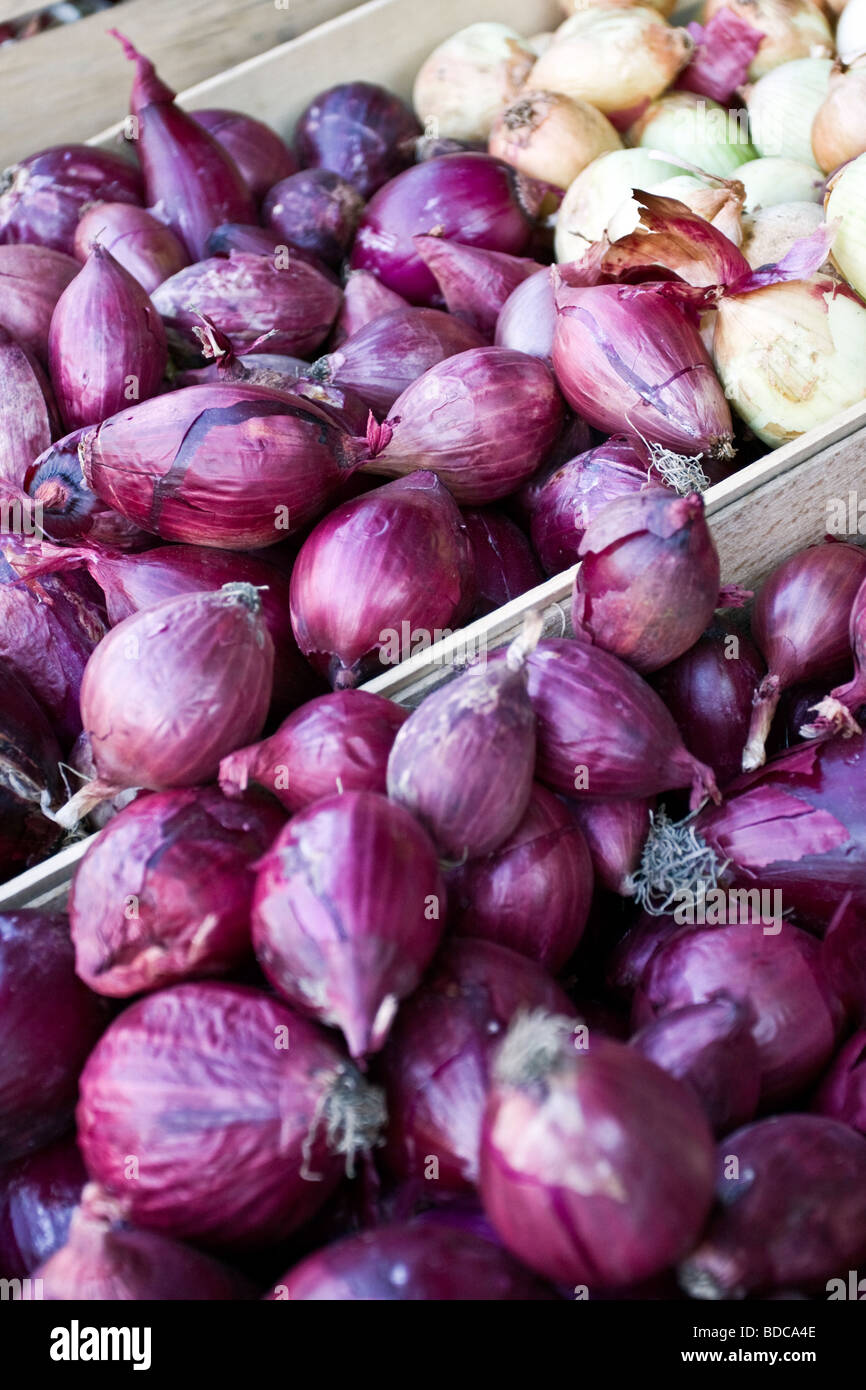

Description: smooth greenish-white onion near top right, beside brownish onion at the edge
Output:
[748,58,833,168]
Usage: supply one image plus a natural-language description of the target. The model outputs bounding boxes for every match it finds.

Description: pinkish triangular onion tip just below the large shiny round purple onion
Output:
[413,236,541,342]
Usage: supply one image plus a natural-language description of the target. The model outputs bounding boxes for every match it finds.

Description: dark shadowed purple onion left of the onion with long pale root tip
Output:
[651,624,763,787]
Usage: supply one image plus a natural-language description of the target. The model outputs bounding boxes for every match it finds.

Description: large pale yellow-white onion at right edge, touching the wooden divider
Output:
[713,275,866,448]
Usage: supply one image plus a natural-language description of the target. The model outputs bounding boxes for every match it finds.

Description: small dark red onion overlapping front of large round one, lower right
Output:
[631,994,760,1134]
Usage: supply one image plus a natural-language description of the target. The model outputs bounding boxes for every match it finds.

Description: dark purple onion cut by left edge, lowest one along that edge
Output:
[0,1138,88,1279]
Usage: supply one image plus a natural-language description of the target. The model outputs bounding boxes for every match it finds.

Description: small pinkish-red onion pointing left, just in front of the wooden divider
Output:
[220,689,409,812]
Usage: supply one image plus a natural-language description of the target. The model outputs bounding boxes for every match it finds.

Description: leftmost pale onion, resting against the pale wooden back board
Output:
[411,24,535,140]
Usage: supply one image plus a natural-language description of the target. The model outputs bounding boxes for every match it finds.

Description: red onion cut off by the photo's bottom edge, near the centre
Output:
[267,1220,556,1302]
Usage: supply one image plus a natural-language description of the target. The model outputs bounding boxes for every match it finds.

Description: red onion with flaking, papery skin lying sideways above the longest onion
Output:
[153,252,341,356]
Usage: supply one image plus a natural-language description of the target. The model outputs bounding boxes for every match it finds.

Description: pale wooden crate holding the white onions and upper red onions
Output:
[0,0,866,910]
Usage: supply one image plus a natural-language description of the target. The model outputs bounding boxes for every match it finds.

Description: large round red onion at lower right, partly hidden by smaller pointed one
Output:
[632,920,842,1106]
